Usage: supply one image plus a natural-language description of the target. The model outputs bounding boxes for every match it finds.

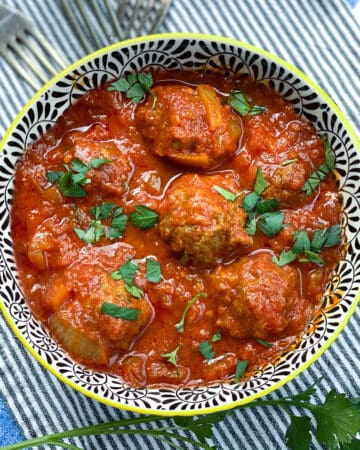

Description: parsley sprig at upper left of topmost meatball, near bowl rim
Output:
[108,72,156,107]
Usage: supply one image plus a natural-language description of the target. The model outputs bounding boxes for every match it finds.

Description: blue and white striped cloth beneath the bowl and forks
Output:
[0,0,360,450]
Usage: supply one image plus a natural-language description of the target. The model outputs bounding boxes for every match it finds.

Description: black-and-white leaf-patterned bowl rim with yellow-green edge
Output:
[0,34,360,415]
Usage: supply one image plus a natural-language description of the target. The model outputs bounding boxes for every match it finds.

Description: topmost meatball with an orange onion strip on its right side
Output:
[136,85,242,169]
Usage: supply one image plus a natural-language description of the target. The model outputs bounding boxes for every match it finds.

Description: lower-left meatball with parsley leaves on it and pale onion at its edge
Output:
[45,264,152,364]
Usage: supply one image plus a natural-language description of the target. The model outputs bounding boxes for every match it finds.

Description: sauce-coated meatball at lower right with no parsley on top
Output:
[211,252,311,340]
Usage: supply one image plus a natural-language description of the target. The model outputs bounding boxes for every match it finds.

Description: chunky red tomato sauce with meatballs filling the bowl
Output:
[12,72,341,386]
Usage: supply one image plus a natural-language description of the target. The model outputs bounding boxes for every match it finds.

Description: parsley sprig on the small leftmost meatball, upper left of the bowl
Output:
[46,158,111,197]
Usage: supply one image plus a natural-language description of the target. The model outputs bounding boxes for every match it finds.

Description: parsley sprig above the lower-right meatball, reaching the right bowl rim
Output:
[271,224,341,267]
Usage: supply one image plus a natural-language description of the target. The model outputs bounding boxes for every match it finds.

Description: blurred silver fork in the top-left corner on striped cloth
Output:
[0,5,67,89]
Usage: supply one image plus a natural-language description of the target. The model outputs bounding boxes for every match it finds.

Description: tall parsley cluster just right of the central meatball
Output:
[242,167,285,237]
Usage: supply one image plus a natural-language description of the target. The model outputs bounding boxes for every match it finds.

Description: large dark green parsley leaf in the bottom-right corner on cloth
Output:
[311,390,360,449]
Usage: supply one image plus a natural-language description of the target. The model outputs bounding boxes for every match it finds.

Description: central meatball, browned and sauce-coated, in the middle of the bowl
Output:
[159,174,252,266]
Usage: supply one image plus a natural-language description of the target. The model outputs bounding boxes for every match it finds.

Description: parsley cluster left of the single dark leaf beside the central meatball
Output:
[74,203,127,244]
